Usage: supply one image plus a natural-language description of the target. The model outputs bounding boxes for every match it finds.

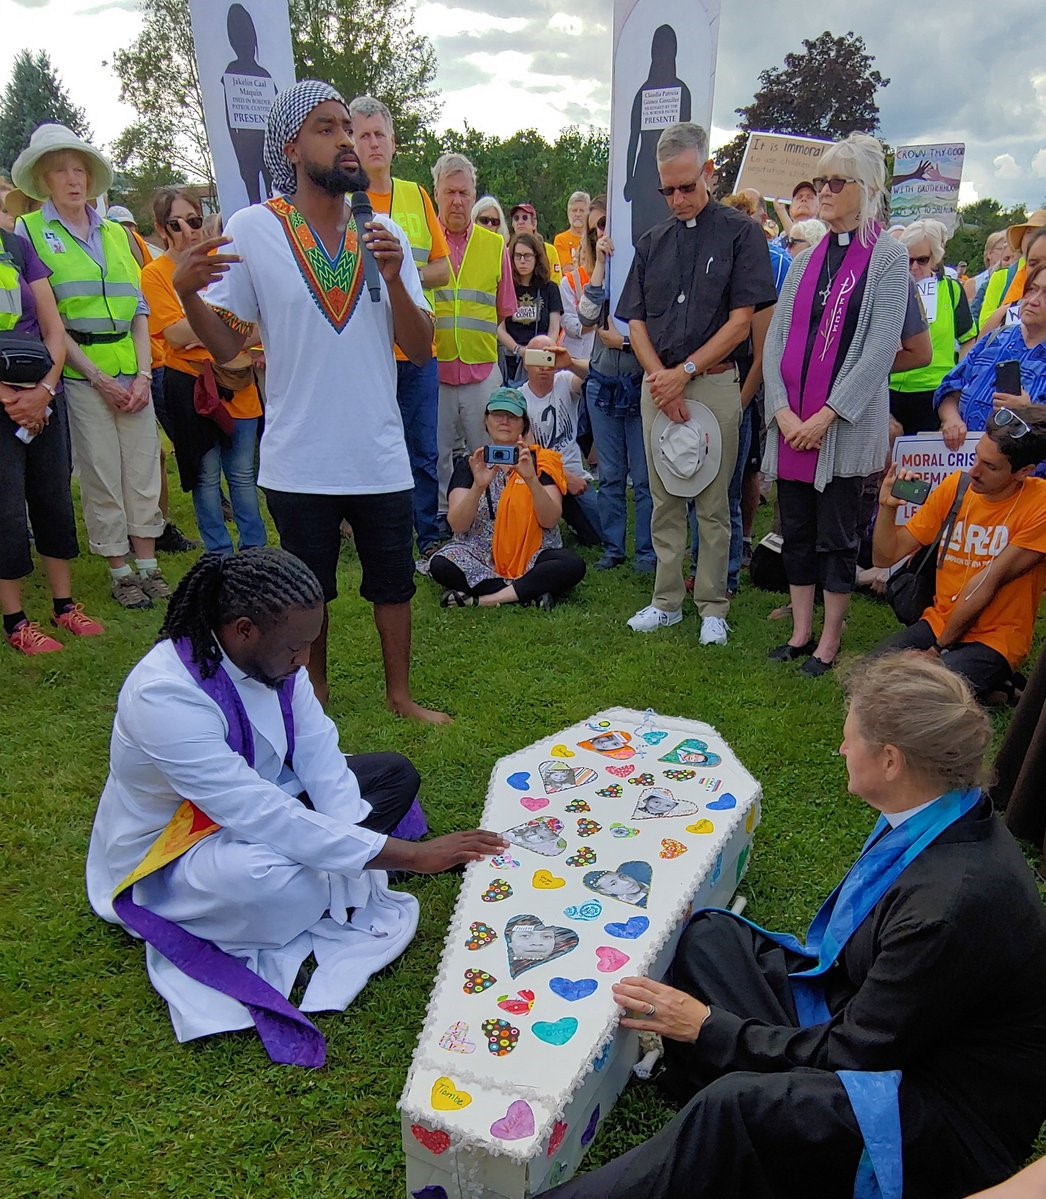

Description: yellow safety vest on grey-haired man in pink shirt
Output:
[434,224,505,364]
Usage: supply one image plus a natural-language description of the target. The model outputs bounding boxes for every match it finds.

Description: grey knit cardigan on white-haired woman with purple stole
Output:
[763,233,909,492]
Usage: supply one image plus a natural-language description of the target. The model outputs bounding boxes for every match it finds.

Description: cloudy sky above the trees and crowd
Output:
[0,0,1046,206]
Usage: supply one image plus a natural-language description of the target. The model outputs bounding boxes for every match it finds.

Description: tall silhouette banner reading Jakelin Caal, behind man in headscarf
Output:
[190,0,294,219]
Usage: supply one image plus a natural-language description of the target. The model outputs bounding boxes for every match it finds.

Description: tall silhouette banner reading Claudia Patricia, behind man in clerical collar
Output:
[608,0,720,326]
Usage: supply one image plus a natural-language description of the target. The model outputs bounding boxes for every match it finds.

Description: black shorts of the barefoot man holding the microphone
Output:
[265,487,415,603]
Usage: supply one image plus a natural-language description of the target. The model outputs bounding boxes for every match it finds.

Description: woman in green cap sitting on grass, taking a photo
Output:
[429,387,585,610]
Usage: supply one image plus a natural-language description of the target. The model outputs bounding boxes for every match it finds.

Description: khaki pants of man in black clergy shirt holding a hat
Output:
[642,372,741,616]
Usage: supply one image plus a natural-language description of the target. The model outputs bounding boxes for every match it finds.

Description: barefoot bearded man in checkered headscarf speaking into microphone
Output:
[174,79,449,724]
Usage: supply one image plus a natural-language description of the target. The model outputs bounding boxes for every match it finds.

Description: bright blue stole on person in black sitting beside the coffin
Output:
[705,788,981,1199]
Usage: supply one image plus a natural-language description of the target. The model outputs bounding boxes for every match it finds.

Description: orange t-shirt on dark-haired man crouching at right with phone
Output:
[906,471,1046,668]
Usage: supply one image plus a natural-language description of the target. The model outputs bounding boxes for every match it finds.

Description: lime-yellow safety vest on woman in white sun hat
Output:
[19,212,145,379]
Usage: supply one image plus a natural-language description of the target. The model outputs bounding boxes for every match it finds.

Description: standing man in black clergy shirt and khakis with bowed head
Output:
[617,121,777,645]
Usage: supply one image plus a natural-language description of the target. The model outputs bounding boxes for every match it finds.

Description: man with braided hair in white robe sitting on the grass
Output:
[88,549,506,1065]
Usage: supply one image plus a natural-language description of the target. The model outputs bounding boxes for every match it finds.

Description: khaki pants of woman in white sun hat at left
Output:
[64,376,163,558]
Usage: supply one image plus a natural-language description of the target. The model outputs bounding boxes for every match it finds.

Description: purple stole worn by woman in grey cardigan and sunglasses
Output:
[777,224,879,483]
